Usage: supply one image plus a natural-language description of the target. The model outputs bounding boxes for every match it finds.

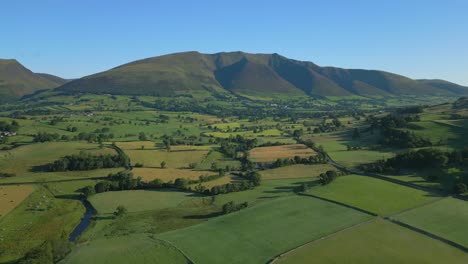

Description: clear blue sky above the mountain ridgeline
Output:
[0,0,468,85]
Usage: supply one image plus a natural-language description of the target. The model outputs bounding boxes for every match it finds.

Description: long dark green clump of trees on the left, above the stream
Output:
[47,152,129,171]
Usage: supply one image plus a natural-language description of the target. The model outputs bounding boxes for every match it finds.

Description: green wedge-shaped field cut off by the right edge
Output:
[394,198,468,247]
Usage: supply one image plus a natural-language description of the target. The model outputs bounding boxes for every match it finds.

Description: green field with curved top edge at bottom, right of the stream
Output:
[60,234,190,264]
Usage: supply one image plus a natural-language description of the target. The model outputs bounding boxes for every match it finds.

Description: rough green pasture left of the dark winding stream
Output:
[0,186,85,263]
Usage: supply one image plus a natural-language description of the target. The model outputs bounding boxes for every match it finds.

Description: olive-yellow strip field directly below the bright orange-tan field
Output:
[260,164,336,180]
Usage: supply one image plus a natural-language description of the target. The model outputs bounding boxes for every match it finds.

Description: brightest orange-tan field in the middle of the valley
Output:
[250,144,317,162]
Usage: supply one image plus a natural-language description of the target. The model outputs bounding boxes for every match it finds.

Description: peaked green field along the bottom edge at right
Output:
[277,220,468,264]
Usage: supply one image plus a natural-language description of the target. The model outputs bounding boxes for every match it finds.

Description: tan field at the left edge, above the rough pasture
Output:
[0,185,34,218]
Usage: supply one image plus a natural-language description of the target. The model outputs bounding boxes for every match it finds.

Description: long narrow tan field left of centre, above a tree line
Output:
[132,168,215,182]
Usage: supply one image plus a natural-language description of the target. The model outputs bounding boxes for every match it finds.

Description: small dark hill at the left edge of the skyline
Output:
[0,59,67,102]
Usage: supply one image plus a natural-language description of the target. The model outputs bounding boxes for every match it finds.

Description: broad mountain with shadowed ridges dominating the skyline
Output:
[53,52,468,98]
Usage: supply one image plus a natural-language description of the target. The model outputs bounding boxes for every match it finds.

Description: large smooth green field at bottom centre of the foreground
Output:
[159,196,369,264]
